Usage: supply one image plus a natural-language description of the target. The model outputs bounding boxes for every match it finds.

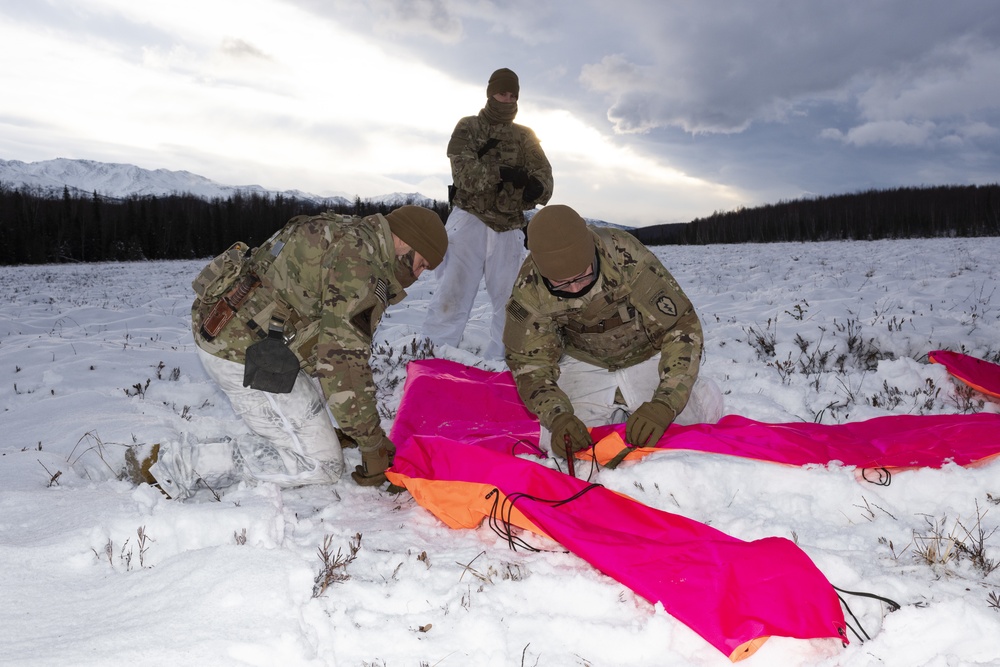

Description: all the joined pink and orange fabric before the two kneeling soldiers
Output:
[387,359,1000,660]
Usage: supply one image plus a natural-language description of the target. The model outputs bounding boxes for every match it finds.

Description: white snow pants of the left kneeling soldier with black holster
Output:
[150,348,344,498]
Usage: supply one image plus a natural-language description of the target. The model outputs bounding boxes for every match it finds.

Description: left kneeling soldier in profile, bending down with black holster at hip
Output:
[127,206,448,498]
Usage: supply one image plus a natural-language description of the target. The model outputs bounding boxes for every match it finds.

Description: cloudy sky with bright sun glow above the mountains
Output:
[0,0,1000,225]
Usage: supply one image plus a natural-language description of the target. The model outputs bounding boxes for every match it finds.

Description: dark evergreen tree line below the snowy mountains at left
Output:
[0,186,448,265]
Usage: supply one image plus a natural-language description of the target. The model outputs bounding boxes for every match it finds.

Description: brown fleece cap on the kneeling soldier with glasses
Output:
[528,204,597,282]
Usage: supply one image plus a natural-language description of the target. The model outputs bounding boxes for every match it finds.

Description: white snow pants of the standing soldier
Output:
[423,208,527,359]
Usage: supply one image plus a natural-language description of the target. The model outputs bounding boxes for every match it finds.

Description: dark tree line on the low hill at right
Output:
[633,185,1000,245]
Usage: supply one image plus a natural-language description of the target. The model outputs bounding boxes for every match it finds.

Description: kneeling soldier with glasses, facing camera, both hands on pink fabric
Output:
[504,205,722,457]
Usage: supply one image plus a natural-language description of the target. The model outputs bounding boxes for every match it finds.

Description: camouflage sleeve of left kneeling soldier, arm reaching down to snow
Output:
[316,235,385,449]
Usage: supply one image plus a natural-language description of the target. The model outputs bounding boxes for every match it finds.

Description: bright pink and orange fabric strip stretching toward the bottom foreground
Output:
[386,434,847,661]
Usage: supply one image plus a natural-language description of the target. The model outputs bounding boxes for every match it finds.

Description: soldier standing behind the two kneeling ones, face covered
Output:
[423,68,552,359]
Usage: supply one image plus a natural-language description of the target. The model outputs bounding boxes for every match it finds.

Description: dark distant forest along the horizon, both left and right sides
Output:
[0,184,1000,265]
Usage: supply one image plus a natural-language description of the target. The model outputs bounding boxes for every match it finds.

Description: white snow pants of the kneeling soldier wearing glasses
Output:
[540,354,724,454]
